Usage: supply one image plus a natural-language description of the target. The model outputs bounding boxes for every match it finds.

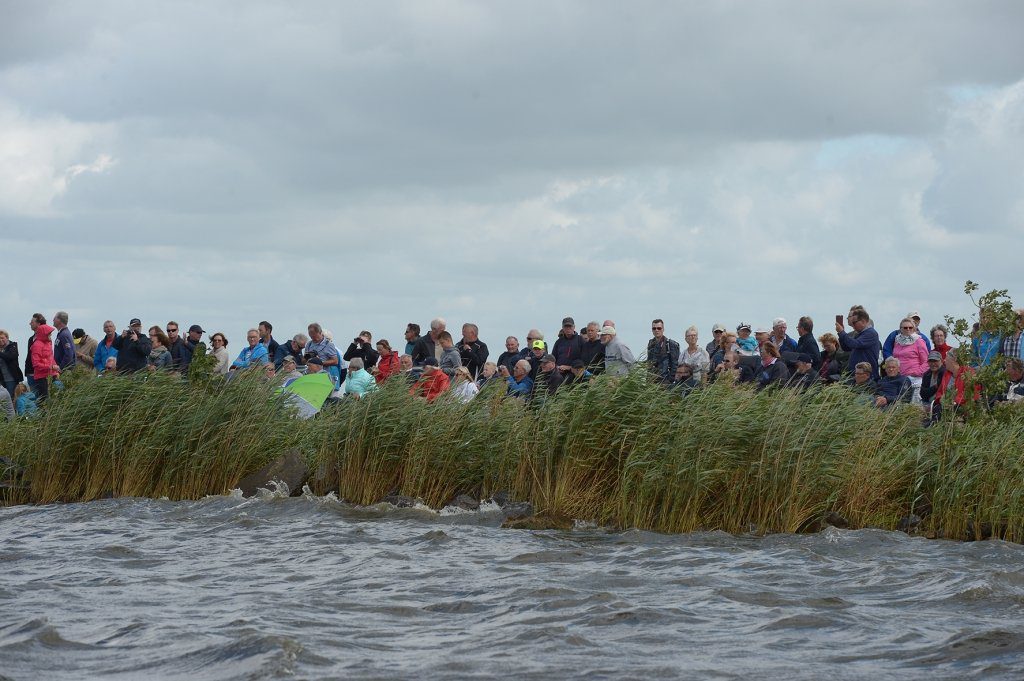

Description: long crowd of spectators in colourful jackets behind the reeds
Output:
[0,305,1024,421]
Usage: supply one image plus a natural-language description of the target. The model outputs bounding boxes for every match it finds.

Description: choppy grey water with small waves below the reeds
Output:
[0,489,1024,681]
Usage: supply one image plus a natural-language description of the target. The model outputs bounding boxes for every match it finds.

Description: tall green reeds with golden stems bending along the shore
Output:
[0,374,1024,542]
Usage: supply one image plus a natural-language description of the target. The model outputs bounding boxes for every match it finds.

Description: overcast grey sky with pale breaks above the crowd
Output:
[0,0,1024,356]
